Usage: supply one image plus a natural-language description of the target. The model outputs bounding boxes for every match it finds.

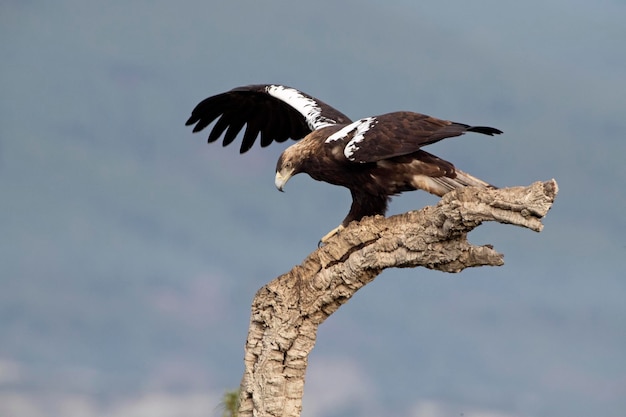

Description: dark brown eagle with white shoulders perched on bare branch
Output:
[186,84,502,243]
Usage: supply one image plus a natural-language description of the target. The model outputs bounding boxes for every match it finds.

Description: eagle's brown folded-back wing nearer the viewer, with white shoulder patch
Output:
[326,112,502,163]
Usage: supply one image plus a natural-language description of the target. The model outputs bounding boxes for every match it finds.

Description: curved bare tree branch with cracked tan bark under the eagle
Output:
[239,180,558,417]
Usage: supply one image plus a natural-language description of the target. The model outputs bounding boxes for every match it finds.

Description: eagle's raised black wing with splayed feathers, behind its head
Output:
[185,84,350,153]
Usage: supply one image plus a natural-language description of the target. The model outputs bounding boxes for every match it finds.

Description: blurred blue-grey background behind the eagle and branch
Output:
[0,0,626,417]
